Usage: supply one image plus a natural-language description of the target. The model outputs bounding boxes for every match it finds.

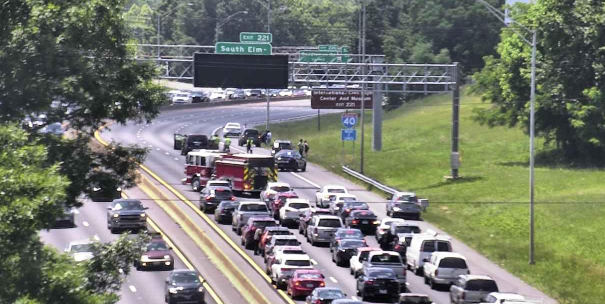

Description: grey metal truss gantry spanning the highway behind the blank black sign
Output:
[133,45,458,94]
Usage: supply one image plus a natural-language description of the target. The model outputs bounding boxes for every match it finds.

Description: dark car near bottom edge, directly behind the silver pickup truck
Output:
[357,267,399,302]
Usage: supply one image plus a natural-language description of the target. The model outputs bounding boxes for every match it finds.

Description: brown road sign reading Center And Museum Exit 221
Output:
[311,90,372,110]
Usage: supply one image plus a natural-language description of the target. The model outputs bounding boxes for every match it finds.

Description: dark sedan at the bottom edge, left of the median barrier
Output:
[164,269,204,303]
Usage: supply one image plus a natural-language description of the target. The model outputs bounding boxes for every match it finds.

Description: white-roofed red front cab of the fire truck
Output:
[181,150,227,191]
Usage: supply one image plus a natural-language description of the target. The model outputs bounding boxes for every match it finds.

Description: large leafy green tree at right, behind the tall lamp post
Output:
[474,0,605,164]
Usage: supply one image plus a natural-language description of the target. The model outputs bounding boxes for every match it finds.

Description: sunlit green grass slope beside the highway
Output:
[270,90,605,304]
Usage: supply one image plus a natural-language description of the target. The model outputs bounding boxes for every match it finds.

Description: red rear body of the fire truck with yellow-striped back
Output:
[214,154,277,194]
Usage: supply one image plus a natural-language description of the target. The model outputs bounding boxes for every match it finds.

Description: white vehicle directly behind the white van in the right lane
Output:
[422,252,470,289]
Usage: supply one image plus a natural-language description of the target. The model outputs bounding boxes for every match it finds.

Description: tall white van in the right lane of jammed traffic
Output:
[406,229,452,275]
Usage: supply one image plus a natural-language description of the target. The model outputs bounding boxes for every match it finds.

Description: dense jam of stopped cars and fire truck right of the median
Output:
[153,123,529,304]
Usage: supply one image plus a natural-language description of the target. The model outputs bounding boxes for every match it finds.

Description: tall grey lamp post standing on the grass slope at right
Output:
[477,0,537,264]
